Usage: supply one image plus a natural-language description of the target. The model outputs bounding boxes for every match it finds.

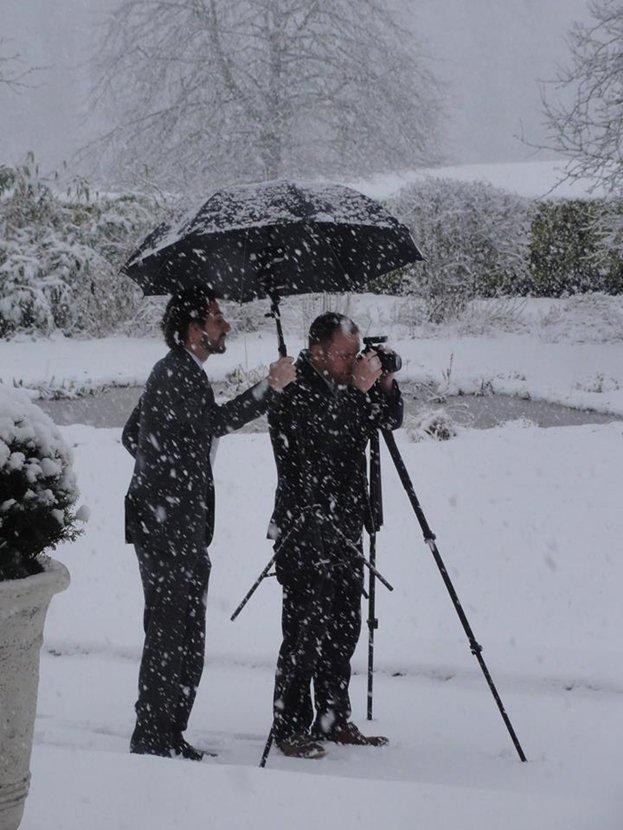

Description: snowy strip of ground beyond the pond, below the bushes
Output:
[0,294,623,415]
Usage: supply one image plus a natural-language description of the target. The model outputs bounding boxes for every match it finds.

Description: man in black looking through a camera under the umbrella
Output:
[268,312,403,758]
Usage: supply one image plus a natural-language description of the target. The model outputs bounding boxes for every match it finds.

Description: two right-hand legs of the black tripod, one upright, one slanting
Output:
[367,430,526,761]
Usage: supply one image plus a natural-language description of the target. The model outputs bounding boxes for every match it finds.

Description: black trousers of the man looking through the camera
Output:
[273,561,363,741]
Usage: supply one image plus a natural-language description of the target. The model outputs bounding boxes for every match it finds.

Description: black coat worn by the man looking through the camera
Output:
[268,351,403,539]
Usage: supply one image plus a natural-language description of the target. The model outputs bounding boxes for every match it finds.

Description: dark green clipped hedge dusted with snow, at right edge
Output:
[528,199,623,297]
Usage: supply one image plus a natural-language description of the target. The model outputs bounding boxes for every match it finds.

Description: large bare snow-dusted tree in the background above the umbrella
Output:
[89,0,439,189]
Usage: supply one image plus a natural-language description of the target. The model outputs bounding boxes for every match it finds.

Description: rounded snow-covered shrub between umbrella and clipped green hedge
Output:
[386,178,530,322]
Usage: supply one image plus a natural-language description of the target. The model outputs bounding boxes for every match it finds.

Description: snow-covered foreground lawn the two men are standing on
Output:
[23,422,623,830]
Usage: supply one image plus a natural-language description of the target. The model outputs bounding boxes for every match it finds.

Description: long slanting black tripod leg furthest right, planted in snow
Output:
[383,430,526,761]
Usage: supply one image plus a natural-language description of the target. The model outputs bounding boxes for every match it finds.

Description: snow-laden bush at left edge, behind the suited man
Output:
[0,155,165,337]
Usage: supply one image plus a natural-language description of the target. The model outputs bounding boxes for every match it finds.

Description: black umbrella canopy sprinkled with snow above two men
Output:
[124,181,422,302]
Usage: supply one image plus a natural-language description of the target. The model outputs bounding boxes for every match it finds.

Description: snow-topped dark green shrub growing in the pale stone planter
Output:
[0,384,86,580]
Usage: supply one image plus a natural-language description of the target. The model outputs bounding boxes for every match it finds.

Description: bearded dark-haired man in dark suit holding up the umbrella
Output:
[123,288,295,760]
